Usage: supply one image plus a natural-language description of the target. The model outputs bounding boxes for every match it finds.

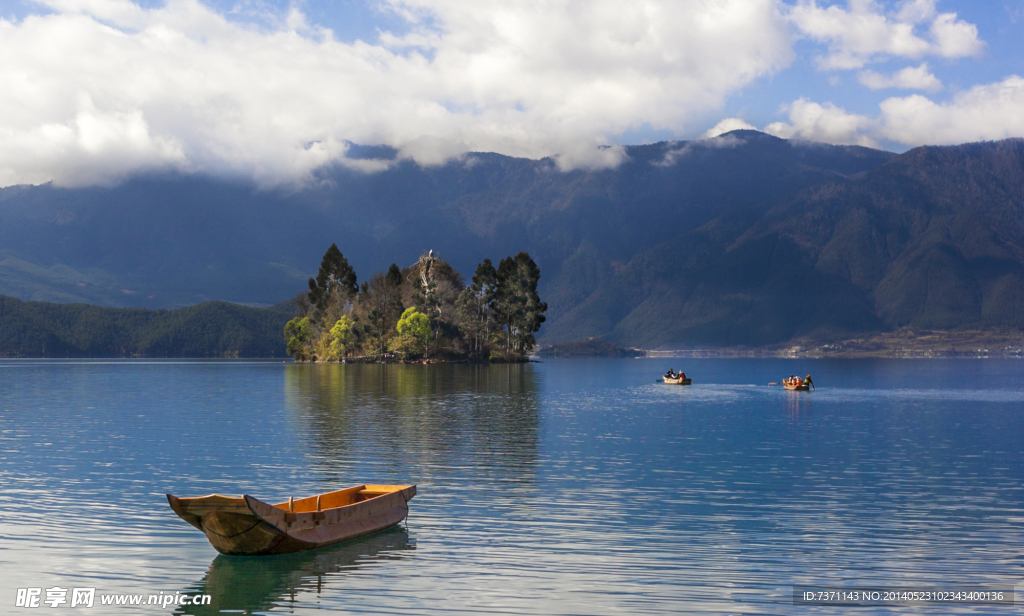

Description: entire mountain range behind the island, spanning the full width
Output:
[0,131,1024,348]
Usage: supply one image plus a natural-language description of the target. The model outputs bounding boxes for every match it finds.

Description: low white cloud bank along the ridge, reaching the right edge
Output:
[765,75,1024,146]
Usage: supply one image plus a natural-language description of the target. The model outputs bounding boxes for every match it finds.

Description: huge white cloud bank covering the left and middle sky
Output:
[0,0,792,185]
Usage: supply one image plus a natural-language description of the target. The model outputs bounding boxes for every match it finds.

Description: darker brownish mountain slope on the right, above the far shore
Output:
[548,139,1024,347]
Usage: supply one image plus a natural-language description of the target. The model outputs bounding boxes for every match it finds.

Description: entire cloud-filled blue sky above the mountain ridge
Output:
[0,0,1024,185]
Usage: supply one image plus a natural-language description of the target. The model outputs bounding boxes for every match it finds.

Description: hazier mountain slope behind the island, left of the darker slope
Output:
[0,131,892,329]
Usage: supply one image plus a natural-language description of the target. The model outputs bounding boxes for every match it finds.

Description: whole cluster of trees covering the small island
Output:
[285,244,547,361]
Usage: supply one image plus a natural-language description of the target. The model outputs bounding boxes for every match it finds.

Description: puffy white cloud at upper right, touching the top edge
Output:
[788,0,984,70]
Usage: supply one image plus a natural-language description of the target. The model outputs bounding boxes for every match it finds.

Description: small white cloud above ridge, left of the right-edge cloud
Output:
[764,98,877,147]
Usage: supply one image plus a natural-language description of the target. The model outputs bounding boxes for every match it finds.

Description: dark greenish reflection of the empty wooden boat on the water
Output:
[174,521,416,616]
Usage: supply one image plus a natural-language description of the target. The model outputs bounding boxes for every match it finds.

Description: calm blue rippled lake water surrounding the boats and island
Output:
[0,359,1024,614]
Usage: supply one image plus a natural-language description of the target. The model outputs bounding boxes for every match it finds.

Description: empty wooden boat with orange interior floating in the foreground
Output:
[167,485,416,556]
